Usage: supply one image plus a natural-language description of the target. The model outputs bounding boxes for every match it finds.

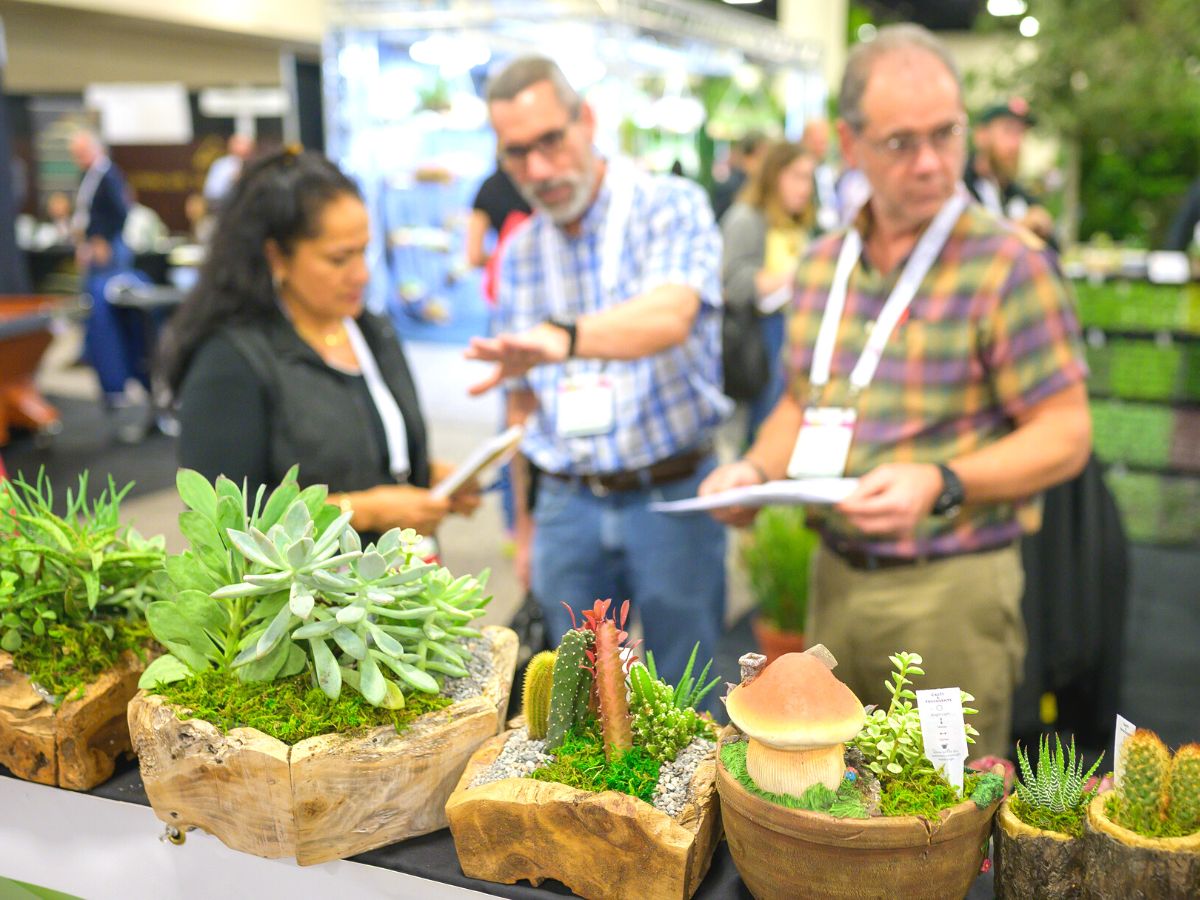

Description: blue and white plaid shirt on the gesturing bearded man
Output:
[497,170,728,475]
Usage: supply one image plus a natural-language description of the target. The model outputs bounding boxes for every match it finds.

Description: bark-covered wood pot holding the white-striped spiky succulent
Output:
[994,798,1084,900]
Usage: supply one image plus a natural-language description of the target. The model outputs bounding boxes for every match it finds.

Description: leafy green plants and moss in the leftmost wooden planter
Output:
[0,472,166,703]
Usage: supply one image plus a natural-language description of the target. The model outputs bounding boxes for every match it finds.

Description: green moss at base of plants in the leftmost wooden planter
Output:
[12,619,154,706]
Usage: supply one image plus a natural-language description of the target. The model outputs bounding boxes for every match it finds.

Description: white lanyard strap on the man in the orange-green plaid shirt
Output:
[809,186,967,394]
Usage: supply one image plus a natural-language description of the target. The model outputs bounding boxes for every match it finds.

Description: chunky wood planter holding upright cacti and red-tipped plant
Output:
[446,732,721,900]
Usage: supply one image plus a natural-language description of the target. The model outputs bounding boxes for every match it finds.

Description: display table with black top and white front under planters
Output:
[0,763,992,900]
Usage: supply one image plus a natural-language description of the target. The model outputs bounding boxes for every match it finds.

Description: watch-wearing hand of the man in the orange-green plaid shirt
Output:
[834,462,942,538]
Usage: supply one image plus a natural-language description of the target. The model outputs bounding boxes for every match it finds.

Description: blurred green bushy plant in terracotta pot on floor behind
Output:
[740,506,820,661]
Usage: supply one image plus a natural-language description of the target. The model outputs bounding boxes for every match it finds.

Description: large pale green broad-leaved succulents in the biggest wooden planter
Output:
[140,468,490,709]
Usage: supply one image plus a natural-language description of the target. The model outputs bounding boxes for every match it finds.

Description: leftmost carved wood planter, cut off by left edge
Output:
[0,650,145,791]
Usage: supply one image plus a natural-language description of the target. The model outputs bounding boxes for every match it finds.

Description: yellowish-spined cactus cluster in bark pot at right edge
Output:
[1105,728,1200,838]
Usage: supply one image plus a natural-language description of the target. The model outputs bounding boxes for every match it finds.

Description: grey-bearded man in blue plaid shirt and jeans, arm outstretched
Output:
[467,56,728,679]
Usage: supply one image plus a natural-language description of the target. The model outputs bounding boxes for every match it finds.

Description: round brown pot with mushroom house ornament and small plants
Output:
[716,646,1004,900]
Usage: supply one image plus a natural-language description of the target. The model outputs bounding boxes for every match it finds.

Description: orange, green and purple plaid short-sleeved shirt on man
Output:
[787,204,1087,557]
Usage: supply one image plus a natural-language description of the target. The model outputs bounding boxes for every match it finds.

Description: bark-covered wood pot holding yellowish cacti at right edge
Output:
[1084,793,1200,900]
